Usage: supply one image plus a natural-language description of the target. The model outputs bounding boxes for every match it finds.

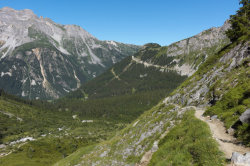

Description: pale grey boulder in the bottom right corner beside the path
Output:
[231,152,250,166]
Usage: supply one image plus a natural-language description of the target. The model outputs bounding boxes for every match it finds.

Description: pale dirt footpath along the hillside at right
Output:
[194,107,250,159]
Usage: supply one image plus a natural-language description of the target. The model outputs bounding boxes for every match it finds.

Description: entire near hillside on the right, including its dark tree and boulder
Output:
[55,3,250,166]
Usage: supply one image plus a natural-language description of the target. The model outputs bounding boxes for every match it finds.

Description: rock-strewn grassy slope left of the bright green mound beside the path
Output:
[55,104,177,166]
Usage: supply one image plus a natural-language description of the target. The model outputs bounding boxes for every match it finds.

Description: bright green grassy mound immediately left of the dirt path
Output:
[149,111,224,166]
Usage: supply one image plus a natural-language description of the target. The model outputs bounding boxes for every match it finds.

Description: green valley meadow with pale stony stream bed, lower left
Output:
[0,95,125,166]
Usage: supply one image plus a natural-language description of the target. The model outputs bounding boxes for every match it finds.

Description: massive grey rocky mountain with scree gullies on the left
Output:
[0,7,140,99]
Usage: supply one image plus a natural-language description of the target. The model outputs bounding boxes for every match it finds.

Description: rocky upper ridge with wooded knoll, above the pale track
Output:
[136,21,230,76]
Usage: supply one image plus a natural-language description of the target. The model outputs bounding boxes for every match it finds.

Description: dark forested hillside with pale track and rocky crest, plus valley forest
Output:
[55,22,229,126]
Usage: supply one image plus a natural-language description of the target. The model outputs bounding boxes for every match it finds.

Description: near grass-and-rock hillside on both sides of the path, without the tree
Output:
[56,42,250,165]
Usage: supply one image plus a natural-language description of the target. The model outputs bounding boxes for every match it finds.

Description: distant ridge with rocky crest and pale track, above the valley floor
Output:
[67,22,229,98]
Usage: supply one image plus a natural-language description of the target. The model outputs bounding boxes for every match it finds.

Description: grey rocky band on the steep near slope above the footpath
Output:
[169,43,249,106]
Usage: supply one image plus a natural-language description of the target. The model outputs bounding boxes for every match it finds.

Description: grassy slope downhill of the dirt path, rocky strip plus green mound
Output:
[55,104,224,166]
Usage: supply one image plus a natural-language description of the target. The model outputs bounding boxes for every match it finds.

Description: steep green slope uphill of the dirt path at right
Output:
[171,41,250,146]
